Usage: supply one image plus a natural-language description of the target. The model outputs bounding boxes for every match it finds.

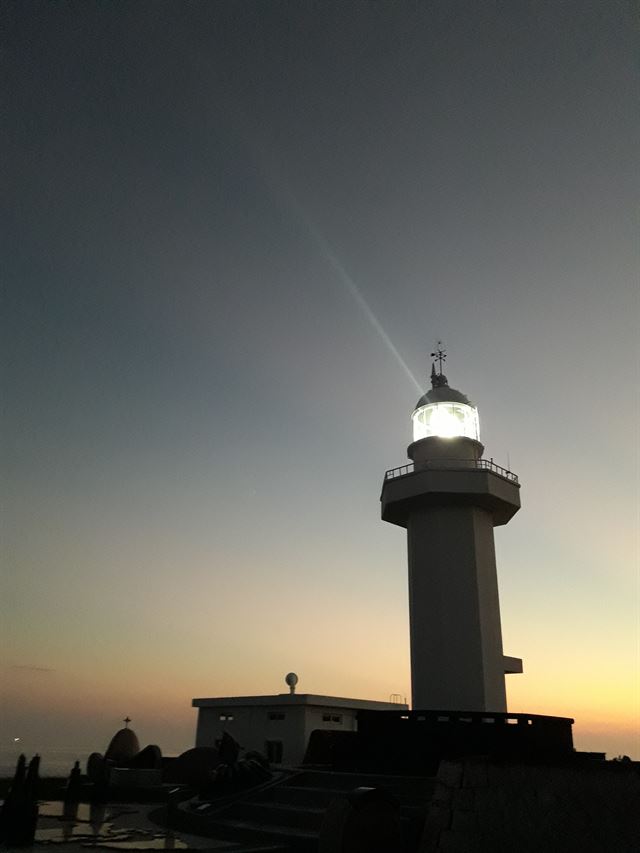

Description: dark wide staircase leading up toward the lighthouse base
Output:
[194,770,434,853]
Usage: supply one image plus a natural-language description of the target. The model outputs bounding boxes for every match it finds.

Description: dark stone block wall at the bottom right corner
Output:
[419,760,640,853]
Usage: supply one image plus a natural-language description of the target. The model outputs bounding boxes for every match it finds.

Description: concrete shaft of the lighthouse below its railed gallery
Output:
[407,506,507,711]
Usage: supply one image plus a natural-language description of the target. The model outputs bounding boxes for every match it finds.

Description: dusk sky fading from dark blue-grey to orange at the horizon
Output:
[0,0,640,759]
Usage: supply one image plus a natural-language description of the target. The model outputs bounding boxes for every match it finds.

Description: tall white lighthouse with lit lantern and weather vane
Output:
[381,345,522,712]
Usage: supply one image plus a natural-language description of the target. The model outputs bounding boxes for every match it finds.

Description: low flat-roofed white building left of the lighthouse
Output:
[192,676,407,766]
